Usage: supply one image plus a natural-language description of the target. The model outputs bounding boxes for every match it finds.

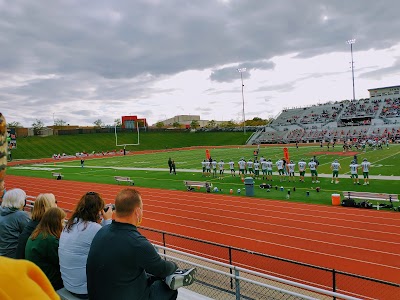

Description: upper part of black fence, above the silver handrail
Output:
[140,228,400,299]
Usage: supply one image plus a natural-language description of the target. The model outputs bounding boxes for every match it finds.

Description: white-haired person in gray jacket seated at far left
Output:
[0,189,30,258]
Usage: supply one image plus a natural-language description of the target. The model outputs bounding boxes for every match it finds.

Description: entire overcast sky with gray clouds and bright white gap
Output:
[0,0,400,126]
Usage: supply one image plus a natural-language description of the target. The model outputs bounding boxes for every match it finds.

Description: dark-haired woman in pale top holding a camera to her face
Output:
[58,192,113,299]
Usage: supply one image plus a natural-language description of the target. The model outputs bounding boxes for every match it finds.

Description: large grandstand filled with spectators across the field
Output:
[248,85,400,144]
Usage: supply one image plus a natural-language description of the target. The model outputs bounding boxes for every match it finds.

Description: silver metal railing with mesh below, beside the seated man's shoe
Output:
[155,245,359,300]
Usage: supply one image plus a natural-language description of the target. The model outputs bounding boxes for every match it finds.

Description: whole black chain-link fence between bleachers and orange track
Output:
[140,228,400,299]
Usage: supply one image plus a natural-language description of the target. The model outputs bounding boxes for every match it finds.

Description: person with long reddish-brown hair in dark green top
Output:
[25,207,66,290]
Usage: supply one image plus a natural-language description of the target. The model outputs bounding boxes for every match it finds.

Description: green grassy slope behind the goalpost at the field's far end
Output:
[12,132,251,159]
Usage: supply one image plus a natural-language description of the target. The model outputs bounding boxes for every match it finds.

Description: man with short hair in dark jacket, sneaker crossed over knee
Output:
[86,188,196,300]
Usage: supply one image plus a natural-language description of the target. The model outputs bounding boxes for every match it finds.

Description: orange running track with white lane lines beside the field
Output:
[6,175,400,299]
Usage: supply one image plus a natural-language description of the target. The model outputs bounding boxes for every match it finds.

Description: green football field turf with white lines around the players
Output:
[7,145,400,204]
